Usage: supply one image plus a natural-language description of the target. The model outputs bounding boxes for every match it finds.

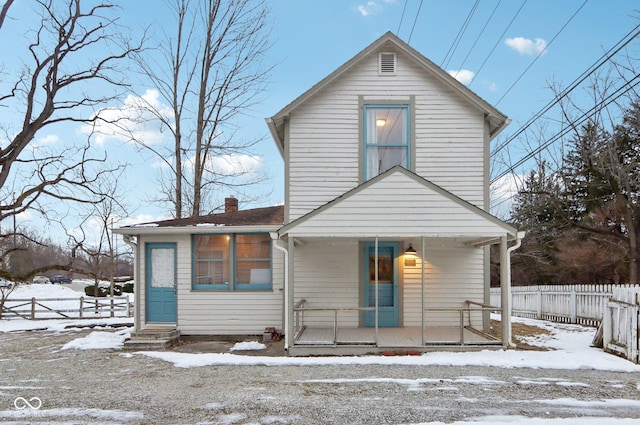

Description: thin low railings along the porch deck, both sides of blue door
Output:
[293,299,502,346]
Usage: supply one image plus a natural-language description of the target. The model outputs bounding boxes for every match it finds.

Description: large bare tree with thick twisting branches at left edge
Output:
[0,0,142,281]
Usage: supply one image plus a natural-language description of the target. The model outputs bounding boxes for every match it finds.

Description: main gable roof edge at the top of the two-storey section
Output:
[266,31,509,153]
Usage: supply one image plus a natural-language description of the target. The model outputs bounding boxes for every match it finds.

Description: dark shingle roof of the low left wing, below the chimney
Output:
[132,205,284,227]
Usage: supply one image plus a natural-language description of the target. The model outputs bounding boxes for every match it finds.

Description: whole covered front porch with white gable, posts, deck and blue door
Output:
[273,167,524,355]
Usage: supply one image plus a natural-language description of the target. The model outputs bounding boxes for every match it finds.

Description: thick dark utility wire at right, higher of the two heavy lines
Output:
[491,24,640,157]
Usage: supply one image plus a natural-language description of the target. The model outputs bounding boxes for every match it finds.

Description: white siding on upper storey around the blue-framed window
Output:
[288,49,485,220]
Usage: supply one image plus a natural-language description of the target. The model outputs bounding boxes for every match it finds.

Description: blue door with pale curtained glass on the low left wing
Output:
[145,243,177,323]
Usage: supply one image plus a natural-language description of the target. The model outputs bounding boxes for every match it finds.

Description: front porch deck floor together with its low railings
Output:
[289,299,503,356]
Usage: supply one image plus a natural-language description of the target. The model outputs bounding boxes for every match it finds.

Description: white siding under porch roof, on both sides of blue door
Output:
[294,238,484,327]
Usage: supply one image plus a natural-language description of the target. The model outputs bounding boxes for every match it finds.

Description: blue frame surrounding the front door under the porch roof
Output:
[360,241,400,328]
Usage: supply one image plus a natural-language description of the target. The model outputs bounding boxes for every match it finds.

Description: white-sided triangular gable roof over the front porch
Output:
[278,166,517,245]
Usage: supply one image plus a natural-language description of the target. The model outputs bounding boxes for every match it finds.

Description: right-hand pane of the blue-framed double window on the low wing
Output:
[236,235,271,286]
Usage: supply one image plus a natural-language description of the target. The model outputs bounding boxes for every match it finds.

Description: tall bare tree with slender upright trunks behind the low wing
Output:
[136,0,270,217]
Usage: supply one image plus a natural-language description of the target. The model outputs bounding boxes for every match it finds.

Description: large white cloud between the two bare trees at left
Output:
[80,90,171,144]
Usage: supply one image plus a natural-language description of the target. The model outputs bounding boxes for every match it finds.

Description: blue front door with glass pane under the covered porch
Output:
[363,242,398,328]
